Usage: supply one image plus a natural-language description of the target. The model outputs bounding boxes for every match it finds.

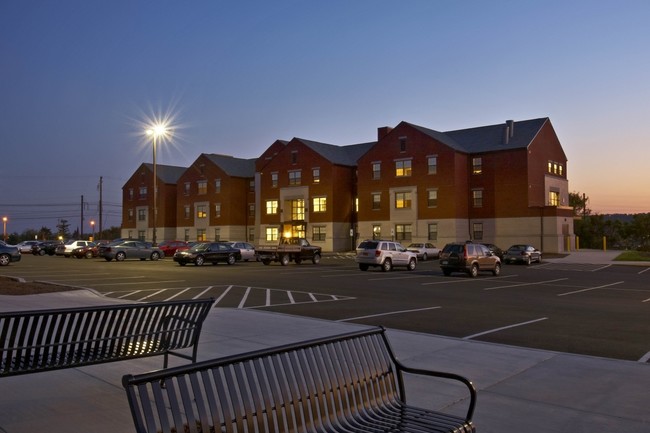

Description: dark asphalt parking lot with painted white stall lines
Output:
[0,255,650,362]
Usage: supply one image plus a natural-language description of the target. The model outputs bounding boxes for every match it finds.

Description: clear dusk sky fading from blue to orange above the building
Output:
[0,0,650,233]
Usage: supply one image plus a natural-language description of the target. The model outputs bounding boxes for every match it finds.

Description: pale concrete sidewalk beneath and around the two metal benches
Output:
[0,291,650,433]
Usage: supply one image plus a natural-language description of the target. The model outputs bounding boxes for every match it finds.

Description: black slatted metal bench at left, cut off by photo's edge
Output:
[0,298,214,377]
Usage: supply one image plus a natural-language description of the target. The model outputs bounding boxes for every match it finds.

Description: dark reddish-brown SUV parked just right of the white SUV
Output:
[440,241,501,277]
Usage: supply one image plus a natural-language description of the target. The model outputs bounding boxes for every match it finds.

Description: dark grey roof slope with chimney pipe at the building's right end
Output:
[405,117,549,153]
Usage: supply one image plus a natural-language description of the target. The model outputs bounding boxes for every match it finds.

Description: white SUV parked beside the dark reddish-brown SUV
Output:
[355,240,418,272]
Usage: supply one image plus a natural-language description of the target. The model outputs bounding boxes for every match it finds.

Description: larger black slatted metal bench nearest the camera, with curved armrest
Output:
[122,328,476,433]
